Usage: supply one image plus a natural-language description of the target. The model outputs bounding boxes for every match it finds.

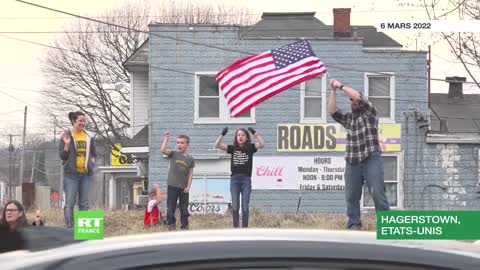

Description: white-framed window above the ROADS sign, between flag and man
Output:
[300,76,327,123]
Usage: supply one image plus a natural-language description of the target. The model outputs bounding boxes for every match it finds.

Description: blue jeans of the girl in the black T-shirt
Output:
[230,175,252,228]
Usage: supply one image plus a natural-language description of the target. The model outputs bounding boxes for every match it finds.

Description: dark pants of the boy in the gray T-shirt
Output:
[167,186,189,229]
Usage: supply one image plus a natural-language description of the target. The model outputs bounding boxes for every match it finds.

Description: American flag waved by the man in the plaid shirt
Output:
[216,41,327,117]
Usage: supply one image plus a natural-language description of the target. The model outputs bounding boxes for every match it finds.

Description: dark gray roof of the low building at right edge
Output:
[431,94,480,133]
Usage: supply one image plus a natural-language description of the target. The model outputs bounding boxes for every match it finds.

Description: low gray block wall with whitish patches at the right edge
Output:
[404,123,480,210]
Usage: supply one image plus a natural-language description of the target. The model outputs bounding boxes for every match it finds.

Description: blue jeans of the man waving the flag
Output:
[345,151,390,228]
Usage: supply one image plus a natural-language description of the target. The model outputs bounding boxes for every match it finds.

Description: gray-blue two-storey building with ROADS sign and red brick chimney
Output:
[125,9,478,213]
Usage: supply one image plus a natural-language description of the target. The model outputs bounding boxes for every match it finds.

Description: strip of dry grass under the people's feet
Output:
[27,209,376,237]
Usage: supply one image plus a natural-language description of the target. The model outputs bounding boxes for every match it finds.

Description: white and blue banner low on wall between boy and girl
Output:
[188,176,232,215]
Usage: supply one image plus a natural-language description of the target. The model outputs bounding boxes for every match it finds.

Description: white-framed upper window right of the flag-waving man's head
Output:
[365,72,395,122]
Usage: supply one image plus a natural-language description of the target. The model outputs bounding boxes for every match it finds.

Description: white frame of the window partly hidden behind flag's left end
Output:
[193,71,255,124]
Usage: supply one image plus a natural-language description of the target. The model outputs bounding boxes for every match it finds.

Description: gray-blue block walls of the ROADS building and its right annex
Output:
[144,25,479,213]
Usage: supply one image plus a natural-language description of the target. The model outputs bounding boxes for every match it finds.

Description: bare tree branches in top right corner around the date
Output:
[422,0,480,88]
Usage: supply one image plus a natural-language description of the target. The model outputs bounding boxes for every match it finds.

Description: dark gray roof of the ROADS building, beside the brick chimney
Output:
[241,12,402,47]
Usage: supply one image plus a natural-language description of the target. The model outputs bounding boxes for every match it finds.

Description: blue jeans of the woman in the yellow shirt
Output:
[63,173,92,228]
